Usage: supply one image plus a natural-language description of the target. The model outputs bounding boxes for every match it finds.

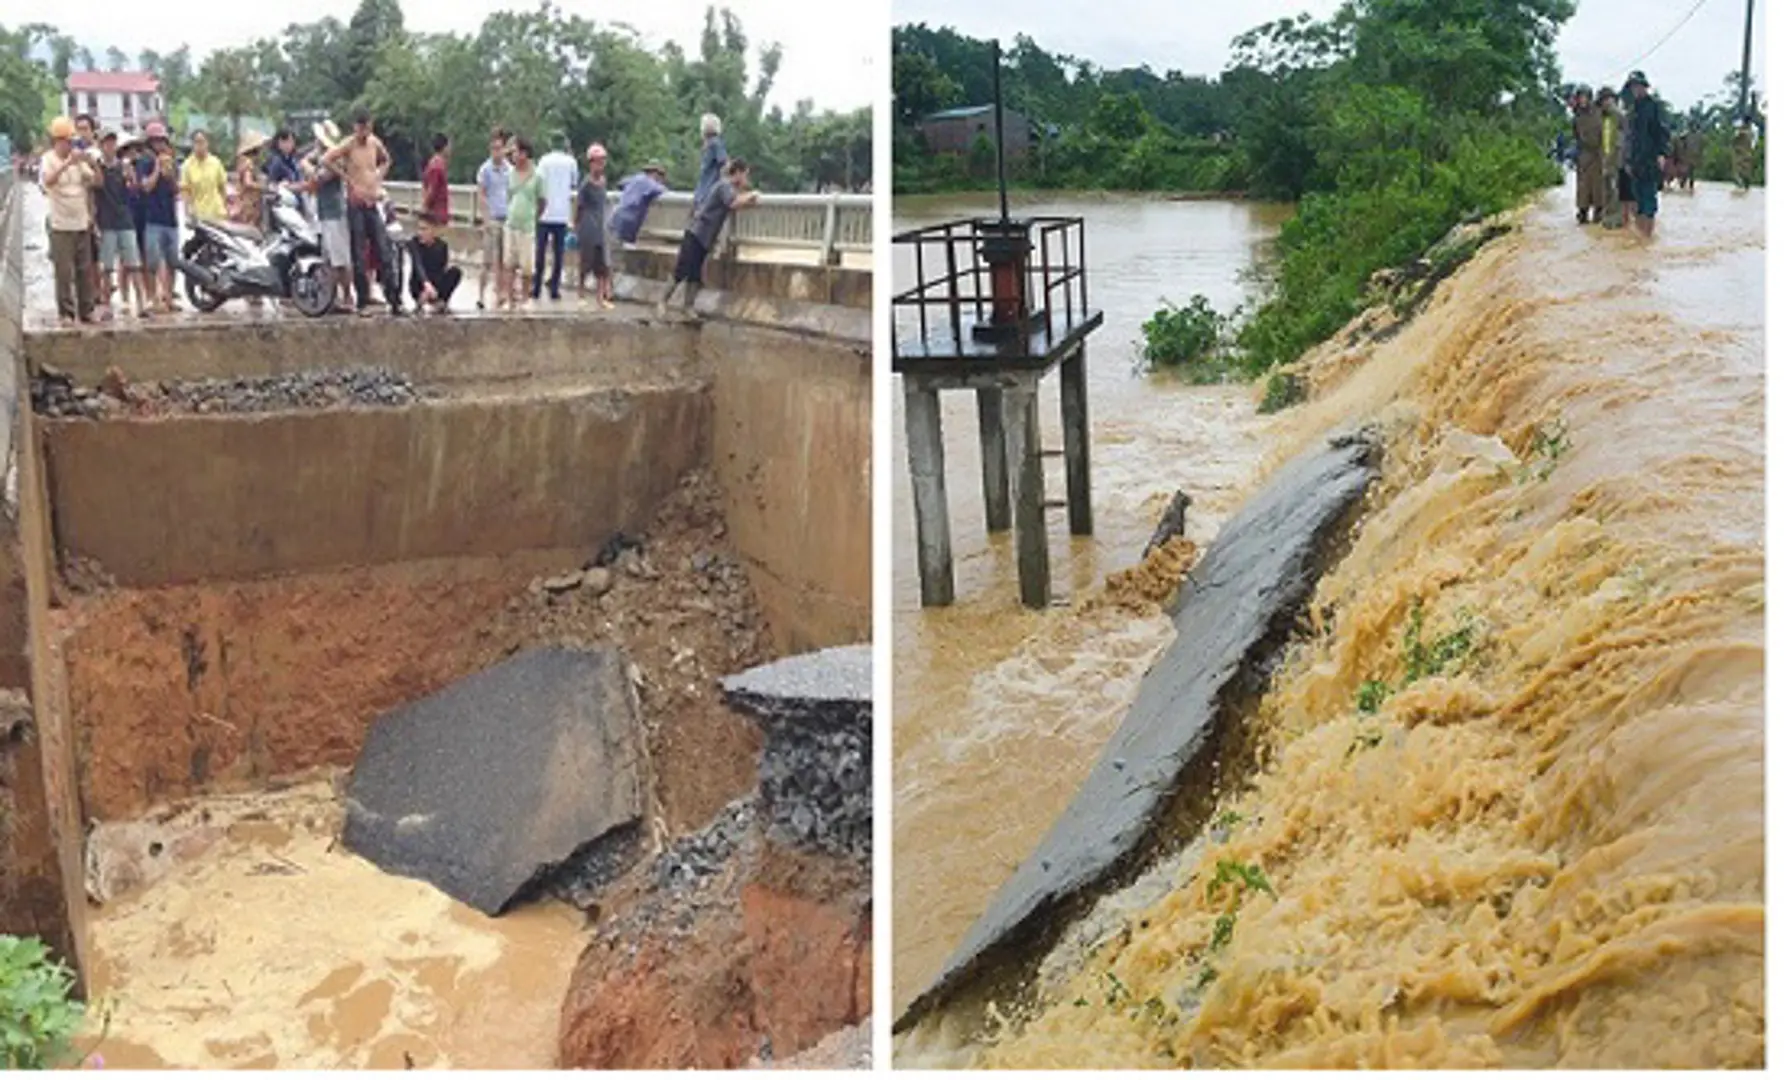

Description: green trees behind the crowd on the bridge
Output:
[0,0,872,191]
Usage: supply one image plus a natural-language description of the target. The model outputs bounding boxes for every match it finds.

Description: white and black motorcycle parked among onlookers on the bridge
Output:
[177,191,334,318]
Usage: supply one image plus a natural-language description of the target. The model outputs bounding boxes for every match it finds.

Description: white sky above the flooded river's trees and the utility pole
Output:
[892,0,1764,105]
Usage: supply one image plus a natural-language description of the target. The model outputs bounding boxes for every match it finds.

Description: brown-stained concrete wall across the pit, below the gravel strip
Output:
[45,384,710,587]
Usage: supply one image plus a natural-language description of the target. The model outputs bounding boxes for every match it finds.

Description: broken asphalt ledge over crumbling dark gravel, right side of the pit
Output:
[723,644,874,862]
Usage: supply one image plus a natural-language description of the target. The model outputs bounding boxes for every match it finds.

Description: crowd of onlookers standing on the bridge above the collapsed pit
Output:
[16,109,758,325]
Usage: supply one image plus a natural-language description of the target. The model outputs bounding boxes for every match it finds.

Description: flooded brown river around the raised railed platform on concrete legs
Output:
[892,196,1288,1009]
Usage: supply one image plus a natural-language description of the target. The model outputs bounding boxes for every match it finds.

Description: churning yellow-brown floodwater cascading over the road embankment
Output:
[901,186,1764,1068]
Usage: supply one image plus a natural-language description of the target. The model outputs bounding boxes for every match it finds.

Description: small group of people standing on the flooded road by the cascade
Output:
[1568,71,1754,237]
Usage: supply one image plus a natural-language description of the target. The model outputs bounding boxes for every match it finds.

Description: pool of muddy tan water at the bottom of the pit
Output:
[89,778,583,1069]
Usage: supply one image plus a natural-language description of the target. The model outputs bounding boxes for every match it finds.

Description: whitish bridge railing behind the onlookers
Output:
[384,180,874,266]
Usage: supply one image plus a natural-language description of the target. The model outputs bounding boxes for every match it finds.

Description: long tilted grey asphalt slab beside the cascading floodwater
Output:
[894,424,1379,1030]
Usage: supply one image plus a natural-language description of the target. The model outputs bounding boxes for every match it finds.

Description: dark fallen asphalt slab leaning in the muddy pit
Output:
[343,648,644,916]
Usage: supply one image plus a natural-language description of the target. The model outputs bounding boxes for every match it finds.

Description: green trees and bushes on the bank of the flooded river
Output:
[977,0,1573,389]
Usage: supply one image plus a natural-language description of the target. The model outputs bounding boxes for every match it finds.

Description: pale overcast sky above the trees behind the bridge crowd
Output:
[10,0,887,111]
